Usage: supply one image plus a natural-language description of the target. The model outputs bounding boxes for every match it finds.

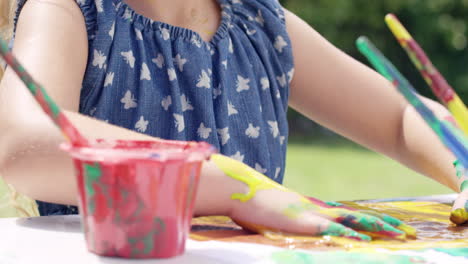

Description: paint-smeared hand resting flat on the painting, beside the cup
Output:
[212,155,414,240]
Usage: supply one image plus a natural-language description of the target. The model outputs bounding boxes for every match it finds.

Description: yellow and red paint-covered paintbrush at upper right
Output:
[385,14,468,134]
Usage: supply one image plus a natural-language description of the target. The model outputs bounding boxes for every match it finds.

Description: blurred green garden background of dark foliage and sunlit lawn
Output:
[280,0,468,200]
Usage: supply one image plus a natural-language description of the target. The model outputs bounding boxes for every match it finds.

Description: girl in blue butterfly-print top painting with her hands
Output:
[0,0,464,239]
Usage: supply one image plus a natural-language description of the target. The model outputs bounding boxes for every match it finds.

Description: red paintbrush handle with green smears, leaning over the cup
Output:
[0,37,89,146]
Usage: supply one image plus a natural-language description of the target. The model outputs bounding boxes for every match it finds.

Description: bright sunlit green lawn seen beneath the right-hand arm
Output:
[284,141,452,200]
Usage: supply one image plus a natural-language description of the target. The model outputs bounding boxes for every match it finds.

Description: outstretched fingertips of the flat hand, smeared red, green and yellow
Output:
[319,209,407,240]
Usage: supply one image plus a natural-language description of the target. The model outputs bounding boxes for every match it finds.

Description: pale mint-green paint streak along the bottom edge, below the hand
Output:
[270,250,429,264]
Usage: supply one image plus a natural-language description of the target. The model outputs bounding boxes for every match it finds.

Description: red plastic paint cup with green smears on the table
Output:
[62,140,214,258]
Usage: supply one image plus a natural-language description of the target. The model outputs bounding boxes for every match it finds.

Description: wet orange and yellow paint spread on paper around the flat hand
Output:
[191,197,468,252]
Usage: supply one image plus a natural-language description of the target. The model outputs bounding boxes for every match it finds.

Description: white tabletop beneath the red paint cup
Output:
[0,195,468,264]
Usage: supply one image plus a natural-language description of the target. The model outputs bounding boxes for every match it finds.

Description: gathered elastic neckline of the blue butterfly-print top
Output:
[114,0,233,46]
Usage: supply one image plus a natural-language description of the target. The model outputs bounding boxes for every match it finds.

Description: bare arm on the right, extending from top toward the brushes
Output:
[286,11,460,191]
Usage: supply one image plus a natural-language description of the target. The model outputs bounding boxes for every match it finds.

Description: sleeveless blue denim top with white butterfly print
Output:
[18,0,294,214]
